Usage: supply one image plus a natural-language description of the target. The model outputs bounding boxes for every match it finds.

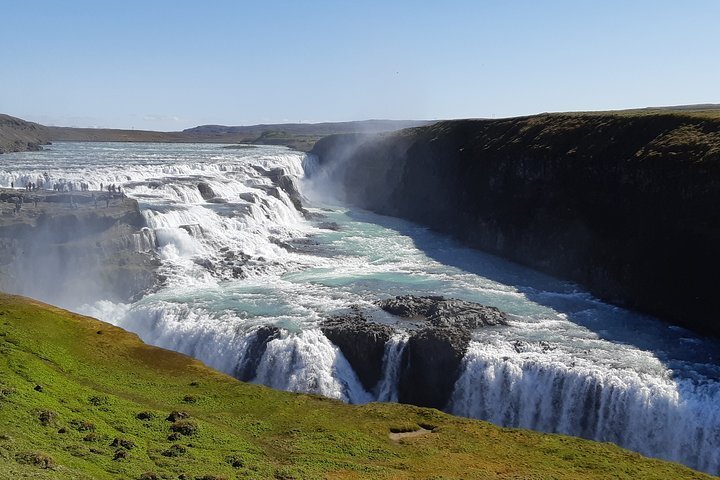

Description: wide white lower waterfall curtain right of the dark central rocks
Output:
[448,342,720,472]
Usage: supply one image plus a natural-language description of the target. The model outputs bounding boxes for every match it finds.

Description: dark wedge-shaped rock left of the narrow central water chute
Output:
[321,310,395,391]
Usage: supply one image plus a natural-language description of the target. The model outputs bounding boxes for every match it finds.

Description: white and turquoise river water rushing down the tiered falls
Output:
[0,143,720,474]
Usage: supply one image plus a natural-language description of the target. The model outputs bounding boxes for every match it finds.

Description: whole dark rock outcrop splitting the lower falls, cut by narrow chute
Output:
[321,295,507,409]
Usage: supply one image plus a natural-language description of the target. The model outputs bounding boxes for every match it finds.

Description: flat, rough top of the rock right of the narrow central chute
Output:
[377,295,507,330]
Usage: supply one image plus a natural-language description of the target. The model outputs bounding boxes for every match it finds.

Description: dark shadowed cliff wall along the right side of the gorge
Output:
[313,113,720,335]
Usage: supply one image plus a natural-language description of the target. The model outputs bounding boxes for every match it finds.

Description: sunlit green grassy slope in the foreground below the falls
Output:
[0,294,710,479]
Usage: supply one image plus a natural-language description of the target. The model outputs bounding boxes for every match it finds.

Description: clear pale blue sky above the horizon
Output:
[0,0,720,130]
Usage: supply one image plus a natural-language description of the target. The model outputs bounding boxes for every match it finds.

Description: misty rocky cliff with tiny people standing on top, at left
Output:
[0,189,158,307]
